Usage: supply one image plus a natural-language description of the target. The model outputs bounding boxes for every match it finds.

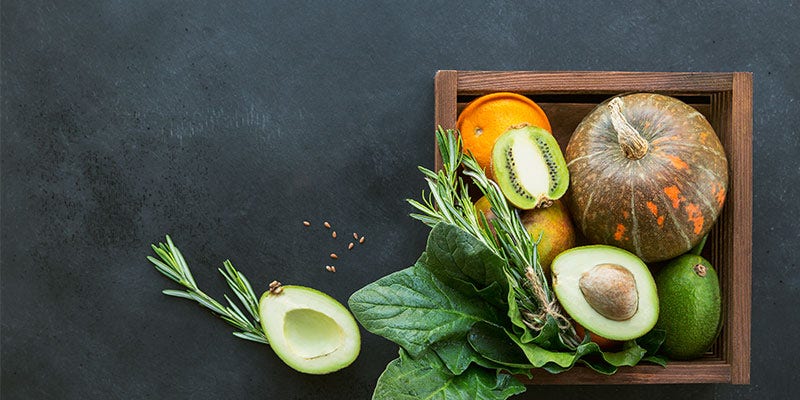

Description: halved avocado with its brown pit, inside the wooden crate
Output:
[551,245,658,340]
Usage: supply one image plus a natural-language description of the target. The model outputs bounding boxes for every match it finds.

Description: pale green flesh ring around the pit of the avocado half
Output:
[551,245,658,340]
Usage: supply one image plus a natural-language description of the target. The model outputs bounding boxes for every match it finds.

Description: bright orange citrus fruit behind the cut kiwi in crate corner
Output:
[456,92,553,170]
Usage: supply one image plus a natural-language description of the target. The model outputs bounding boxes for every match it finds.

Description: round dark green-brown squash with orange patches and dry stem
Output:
[565,93,728,262]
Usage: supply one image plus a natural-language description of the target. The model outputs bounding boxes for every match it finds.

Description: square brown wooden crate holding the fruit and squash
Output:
[435,71,753,385]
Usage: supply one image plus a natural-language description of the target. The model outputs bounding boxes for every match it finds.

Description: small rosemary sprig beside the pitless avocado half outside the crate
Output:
[147,236,269,344]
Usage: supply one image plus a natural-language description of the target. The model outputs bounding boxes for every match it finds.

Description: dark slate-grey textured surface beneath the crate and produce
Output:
[0,0,800,400]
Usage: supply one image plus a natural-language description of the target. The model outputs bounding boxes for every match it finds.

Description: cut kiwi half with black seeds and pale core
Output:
[492,125,569,210]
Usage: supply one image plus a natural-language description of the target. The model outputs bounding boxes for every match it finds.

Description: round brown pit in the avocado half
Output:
[578,263,639,321]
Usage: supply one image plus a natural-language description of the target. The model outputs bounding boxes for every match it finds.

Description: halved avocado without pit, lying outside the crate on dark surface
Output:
[259,285,361,375]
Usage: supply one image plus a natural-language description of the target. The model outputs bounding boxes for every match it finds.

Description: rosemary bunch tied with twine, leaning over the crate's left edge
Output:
[408,127,580,346]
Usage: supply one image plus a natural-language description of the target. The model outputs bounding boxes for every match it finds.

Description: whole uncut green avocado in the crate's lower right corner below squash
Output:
[656,254,722,360]
